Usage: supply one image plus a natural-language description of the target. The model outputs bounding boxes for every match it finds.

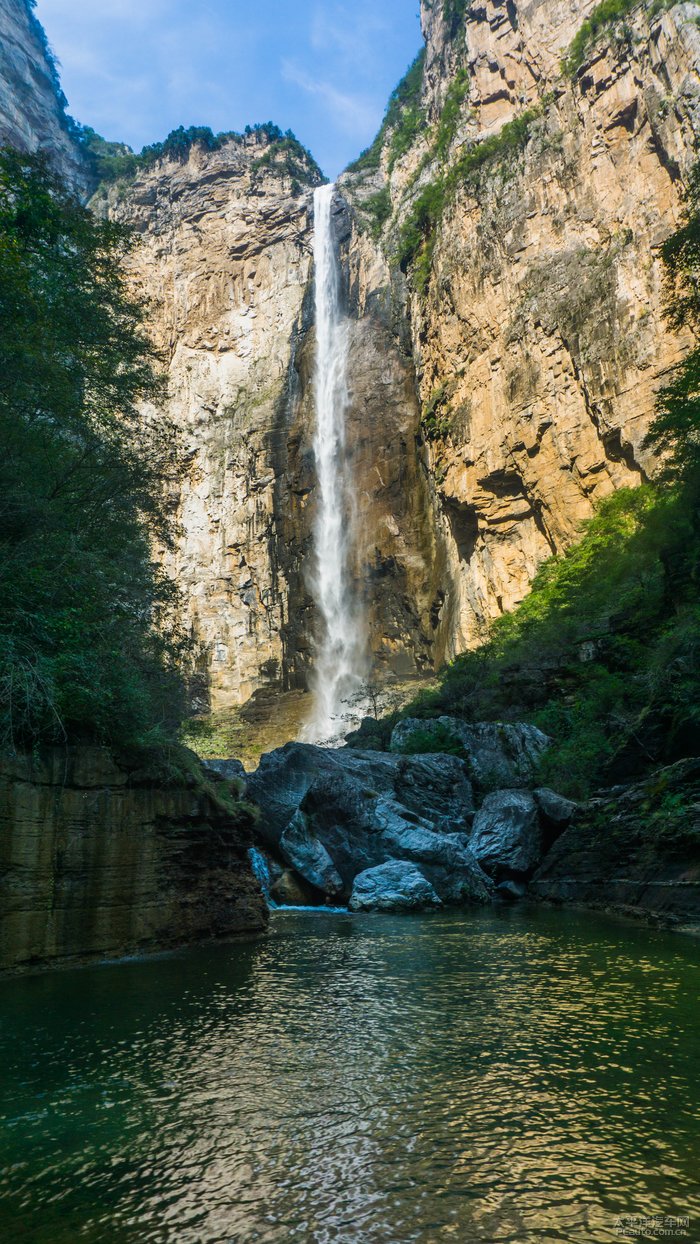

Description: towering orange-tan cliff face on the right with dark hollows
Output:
[344,0,700,652]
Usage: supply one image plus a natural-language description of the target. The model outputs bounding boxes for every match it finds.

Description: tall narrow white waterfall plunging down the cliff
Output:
[303,185,366,743]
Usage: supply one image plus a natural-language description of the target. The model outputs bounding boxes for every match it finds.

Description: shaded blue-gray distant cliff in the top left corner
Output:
[0,0,90,194]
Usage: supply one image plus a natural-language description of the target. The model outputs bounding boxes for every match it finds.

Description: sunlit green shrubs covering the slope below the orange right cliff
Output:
[366,172,700,796]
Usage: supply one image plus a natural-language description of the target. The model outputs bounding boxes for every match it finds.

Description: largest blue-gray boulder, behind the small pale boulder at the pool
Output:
[249,744,492,902]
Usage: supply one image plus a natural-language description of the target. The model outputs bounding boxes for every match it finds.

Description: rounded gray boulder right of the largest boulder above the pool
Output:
[469,790,543,881]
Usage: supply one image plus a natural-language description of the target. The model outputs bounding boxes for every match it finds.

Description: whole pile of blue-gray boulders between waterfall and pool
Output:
[214,718,574,912]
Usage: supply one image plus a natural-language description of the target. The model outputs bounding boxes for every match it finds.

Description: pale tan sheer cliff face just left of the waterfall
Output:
[97,138,320,707]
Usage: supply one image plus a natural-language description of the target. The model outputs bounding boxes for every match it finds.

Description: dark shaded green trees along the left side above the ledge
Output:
[0,151,185,746]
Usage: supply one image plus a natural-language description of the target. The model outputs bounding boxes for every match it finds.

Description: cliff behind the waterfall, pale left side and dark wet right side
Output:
[101,143,440,709]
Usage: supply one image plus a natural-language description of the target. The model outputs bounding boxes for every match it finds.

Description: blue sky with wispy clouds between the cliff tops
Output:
[36,0,421,177]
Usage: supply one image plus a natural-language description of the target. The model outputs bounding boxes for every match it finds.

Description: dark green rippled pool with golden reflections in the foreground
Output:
[0,908,700,1244]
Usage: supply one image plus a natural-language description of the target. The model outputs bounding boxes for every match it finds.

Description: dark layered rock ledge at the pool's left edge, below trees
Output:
[0,748,267,969]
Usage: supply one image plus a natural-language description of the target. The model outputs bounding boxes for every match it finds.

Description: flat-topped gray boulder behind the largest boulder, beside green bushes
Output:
[389,717,551,790]
